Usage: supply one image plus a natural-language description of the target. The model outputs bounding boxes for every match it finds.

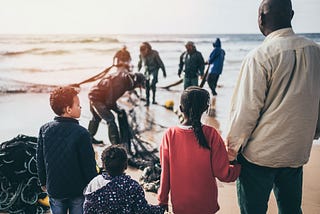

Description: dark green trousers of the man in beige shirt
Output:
[237,155,303,214]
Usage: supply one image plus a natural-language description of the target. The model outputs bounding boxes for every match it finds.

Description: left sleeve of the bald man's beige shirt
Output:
[227,55,268,151]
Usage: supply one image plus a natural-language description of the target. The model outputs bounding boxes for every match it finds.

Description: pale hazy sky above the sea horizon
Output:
[0,0,320,34]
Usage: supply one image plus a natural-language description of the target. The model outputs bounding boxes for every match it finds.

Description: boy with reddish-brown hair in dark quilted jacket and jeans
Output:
[37,87,97,214]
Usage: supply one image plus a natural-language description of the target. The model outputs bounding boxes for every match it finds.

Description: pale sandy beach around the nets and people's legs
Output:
[0,86,320,214]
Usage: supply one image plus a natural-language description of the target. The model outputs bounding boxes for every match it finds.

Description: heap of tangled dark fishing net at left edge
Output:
[0,135,49,214]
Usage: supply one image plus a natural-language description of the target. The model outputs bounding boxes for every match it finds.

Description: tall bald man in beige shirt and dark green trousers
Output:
[227,0,320,214]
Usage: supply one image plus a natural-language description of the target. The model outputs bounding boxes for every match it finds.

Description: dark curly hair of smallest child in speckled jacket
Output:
[101,145,128,176]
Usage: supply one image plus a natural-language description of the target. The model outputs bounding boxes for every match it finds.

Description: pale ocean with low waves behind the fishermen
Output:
[0,34,320,143]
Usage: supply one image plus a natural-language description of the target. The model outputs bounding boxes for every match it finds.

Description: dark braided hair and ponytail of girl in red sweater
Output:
[180,86,210,149]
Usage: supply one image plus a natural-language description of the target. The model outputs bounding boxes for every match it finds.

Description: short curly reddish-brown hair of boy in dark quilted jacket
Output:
[50,86,78,116]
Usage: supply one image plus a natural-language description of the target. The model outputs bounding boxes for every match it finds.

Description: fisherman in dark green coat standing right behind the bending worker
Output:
[138,42,167,106]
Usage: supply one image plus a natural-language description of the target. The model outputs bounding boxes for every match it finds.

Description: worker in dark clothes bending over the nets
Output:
[88,66,145,144]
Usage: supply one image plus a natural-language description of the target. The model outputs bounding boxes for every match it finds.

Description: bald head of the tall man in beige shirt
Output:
[258,0,294,36]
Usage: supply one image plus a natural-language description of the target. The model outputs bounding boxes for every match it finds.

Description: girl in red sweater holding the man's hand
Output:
[158,86,241,214]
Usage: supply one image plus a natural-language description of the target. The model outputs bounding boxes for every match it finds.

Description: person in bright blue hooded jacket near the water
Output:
[207,38,225,96]
